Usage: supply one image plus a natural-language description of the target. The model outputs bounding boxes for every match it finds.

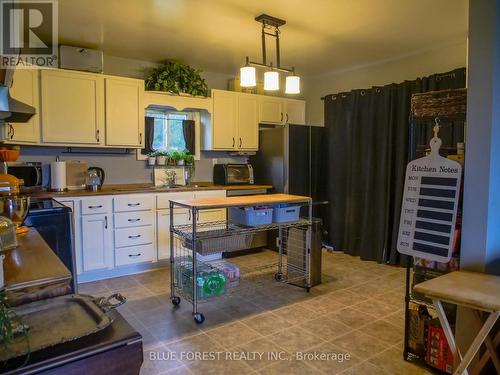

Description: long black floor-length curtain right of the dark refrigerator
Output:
[325,68,465,264]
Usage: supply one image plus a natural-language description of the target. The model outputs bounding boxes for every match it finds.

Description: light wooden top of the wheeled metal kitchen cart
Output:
[172,194,311,209]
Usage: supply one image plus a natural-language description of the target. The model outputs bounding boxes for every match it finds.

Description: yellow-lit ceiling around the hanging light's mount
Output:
[59,0,467,74]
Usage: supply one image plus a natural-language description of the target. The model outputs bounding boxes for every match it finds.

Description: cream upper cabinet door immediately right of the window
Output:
[211,90,238,150]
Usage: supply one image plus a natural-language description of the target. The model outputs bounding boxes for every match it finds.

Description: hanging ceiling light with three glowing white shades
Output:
[240,14,300,94]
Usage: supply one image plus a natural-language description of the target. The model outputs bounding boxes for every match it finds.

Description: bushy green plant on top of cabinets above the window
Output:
[145,60,208,96]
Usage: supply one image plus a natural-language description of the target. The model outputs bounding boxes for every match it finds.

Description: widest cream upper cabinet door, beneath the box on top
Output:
[41,69,104,145]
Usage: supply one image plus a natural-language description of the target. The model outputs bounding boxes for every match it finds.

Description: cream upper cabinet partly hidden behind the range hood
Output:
[4,68,40,144]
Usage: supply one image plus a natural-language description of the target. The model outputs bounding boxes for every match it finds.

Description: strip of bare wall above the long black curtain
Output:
[303,39,467,126]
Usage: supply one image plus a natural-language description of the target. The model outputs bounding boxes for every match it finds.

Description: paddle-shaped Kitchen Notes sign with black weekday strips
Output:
[397,134,462,262]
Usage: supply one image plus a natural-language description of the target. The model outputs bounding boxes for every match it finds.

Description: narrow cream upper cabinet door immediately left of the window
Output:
[105,77,144,147]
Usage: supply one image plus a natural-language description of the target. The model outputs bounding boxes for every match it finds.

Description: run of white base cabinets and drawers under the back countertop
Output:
[70,190,226,280]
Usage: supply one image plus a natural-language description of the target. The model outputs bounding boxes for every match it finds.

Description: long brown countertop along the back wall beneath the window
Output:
[30,182,272,198]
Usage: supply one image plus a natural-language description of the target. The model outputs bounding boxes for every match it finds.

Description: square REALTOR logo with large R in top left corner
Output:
[0,0,58,68]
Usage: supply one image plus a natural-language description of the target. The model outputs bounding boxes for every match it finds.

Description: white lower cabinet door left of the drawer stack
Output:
[82,214,113,272]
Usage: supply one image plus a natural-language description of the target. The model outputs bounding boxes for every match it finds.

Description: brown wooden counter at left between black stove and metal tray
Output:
[4,228,71,306]
